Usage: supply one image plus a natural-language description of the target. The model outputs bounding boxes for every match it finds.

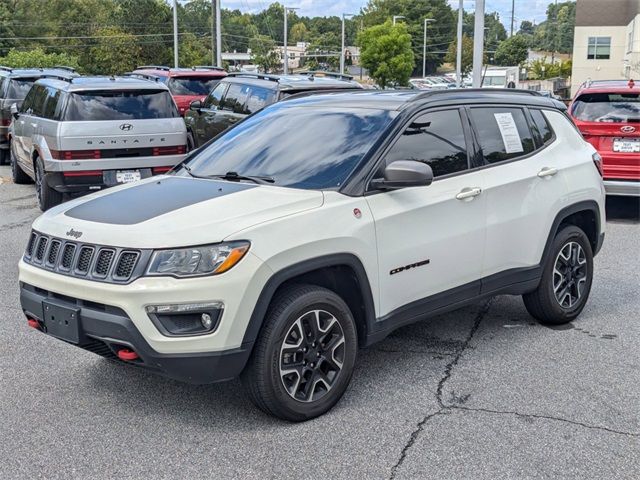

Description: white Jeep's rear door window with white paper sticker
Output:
[470,107,535,164]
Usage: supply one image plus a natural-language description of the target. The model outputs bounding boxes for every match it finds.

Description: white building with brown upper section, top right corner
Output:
[571,0,640,94]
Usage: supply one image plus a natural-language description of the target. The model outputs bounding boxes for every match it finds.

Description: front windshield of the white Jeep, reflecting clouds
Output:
[180,104,395,189]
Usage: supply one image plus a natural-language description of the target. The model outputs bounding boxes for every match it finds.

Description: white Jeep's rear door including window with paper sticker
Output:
[469,105,566,292]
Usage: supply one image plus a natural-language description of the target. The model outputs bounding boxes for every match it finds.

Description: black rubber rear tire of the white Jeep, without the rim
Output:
[522,225,593,325]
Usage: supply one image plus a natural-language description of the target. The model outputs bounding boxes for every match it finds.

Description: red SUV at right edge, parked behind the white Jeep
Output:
[569,80,640,196]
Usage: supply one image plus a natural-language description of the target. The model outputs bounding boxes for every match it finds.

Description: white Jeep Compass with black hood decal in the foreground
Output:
[19,90,605,421]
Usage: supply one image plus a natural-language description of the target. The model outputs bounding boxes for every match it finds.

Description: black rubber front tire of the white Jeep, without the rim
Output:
[240,285,358,422]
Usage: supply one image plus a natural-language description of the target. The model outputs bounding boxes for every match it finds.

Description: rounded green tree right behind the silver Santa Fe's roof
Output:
[91,27,142,75]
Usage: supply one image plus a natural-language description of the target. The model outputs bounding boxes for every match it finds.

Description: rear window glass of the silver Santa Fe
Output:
[65,90,178,121]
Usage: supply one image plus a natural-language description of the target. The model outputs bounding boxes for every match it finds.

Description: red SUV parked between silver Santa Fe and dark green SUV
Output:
[131,65,227,116]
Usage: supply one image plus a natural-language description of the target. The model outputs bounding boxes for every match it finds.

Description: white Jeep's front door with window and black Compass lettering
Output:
[367,108,486,316]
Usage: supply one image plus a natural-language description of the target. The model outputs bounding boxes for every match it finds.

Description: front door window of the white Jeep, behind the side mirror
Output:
[379,110,468,177]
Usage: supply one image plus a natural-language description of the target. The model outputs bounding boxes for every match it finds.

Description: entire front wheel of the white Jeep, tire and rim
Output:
[241,285,358,422]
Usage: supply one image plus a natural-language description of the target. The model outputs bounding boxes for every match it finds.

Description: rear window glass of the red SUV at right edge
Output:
[573,93,640,123]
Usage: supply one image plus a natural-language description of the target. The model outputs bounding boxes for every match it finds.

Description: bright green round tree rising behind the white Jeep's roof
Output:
[357,21,415,88]
